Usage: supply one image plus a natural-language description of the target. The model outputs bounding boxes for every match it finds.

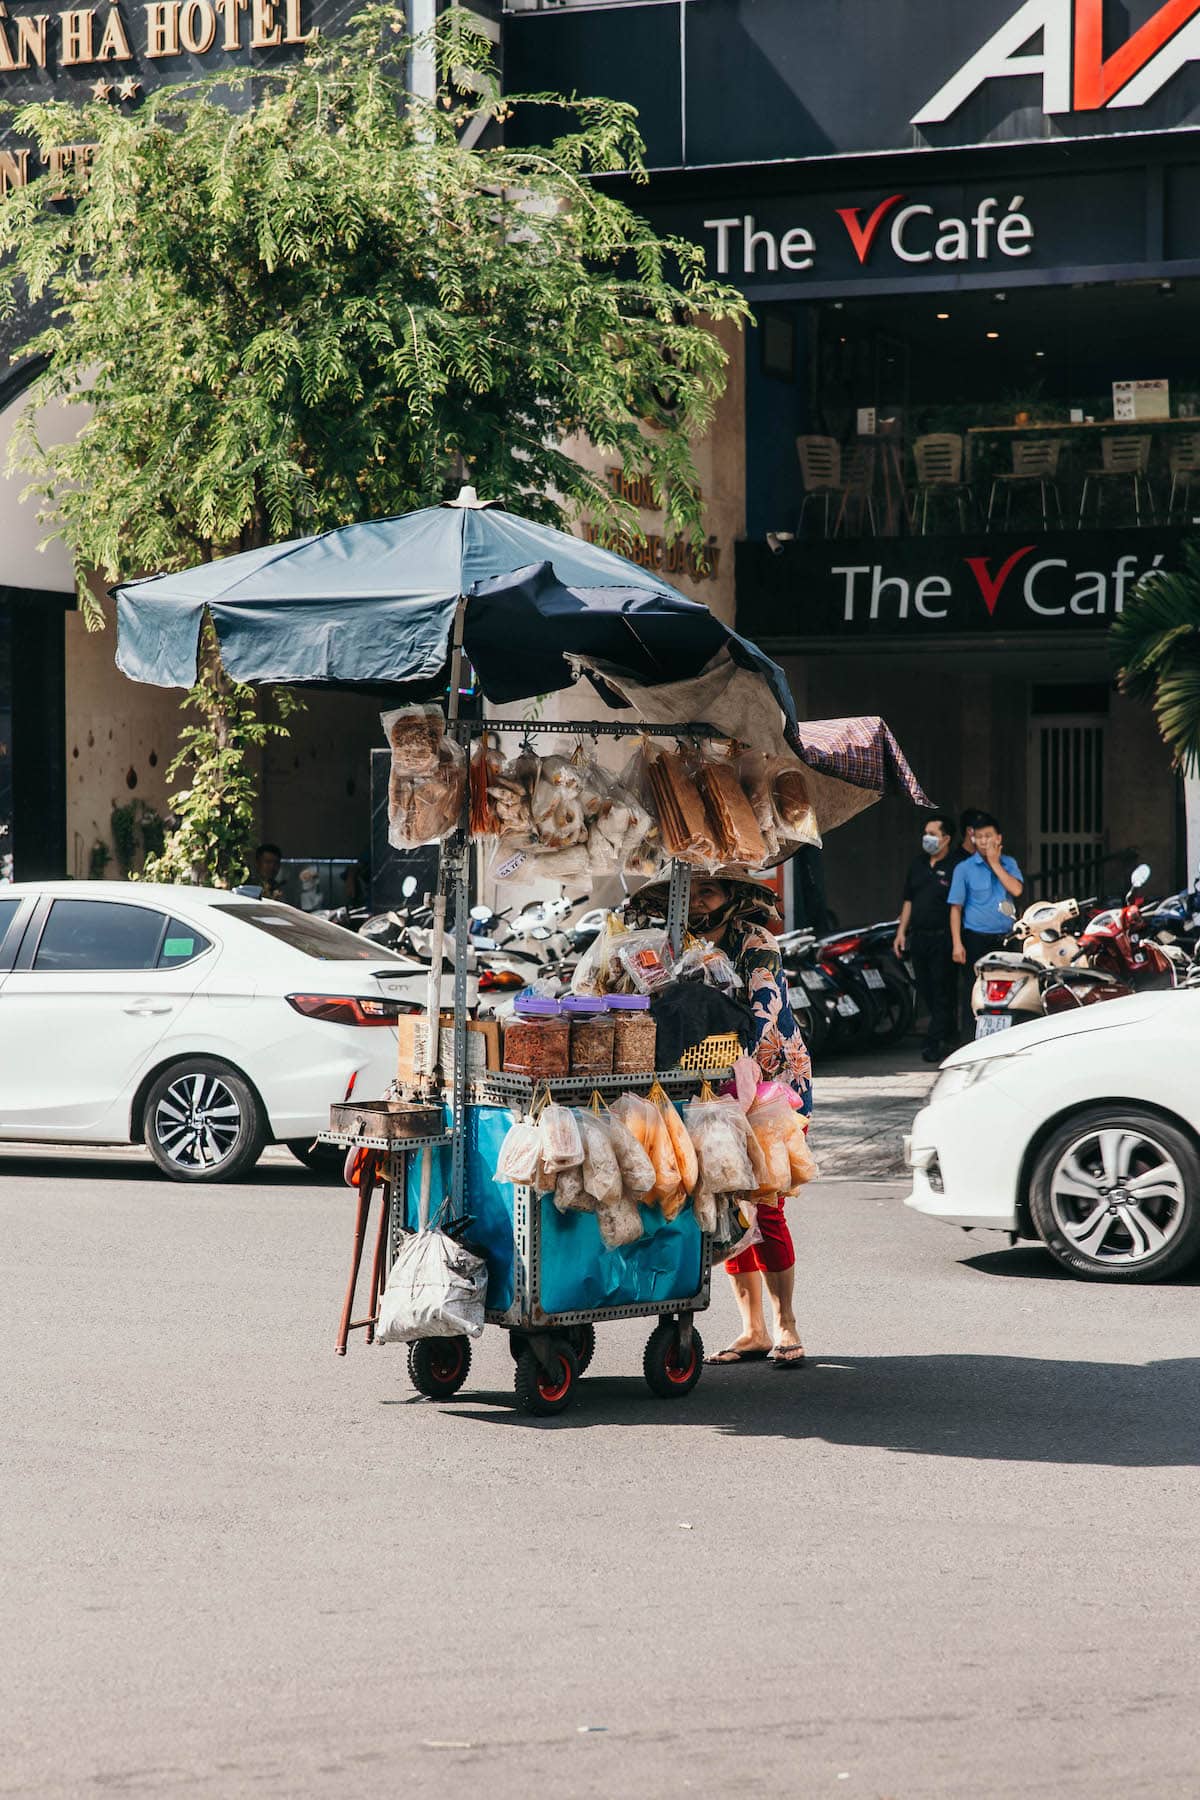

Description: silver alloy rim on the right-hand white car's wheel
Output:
[1051,1125,1187,1267]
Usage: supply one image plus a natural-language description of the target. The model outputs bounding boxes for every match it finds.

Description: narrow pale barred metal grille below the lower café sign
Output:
[1029,715,1105,896]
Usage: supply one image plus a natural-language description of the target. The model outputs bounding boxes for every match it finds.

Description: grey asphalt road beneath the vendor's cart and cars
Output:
[0,1152,1200,1800]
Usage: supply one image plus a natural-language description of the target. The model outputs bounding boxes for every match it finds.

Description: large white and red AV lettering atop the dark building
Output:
[912,0,1200,124]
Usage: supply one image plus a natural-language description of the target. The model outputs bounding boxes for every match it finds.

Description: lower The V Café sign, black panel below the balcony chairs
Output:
[738,527,1186,643]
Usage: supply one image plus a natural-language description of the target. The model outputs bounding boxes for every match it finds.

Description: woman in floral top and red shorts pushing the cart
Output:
[635,871,813,1368]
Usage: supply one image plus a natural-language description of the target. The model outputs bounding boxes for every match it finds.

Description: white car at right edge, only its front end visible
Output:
[907,988,1200,1282]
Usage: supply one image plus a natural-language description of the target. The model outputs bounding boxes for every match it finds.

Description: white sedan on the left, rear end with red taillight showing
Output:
[0,882,422,1181]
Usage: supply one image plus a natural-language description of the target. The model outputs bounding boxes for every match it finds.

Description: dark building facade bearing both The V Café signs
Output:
[504,0,1200,922]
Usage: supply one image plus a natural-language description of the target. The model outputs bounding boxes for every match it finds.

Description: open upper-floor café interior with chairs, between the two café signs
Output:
[747,281,1200,540]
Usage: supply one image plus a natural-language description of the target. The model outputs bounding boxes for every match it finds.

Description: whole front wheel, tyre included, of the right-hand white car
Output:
[1029,1107,1200,1282]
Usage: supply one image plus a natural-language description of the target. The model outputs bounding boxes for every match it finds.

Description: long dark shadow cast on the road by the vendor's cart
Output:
[448,1355,1200,1469]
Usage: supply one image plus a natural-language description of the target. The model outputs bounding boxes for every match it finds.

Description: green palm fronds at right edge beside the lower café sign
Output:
[1108,542,1200,774]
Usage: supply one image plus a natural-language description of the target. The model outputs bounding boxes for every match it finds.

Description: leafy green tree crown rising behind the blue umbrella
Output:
[0,7,747,623]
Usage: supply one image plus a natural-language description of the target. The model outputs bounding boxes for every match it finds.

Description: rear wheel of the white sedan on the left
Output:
[144,1057,266,1181]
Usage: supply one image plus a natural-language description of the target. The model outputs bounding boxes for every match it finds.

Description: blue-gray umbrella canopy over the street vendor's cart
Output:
[115,502,793,716]
